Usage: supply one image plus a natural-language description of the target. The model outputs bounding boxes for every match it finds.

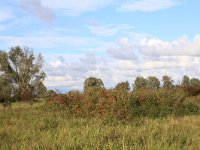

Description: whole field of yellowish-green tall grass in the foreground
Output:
[0,103,200,150]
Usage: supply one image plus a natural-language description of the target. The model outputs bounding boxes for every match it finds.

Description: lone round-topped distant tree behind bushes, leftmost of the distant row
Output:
[84,77,104,91]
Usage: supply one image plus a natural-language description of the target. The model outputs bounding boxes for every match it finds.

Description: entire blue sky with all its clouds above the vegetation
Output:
[0,0,200,91]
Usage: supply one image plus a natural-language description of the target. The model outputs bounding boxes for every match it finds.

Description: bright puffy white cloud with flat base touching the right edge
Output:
[137,35,200,56]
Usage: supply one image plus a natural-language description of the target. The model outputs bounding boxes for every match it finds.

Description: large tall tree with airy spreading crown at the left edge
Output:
[0,46,46,100]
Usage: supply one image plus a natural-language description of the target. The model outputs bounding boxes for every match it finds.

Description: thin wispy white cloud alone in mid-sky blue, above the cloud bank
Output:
[87,24,133,36]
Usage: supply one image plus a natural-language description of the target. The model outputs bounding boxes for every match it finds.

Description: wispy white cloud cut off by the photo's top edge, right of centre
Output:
[117,0,183,12]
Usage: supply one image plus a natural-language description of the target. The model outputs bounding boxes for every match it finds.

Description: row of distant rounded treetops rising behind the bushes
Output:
[84,75,200,96]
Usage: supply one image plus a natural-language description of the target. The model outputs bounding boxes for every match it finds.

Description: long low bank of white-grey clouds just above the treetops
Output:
[41,35,200,89]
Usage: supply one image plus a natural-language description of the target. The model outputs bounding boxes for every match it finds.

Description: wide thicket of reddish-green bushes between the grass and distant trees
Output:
[48,76,200,119]
